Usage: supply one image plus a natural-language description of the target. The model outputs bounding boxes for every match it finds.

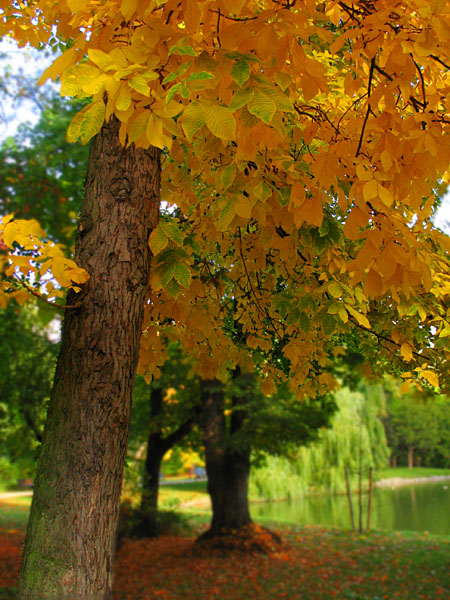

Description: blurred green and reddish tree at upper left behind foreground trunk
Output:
[0,91,88,246]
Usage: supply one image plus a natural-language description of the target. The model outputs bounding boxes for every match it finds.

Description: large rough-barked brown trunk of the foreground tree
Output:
[19,117,161,600]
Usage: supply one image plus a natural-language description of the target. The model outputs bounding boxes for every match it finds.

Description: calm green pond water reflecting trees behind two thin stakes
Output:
[250,481,450,535]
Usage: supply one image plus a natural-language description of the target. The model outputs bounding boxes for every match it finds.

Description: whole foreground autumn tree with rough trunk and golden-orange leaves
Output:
[0,0,450,599]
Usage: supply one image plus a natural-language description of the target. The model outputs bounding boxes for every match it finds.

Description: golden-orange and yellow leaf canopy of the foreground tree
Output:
[0,0,450,394]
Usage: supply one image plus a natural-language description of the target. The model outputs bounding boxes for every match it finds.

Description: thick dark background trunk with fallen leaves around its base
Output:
[203,381,252,537]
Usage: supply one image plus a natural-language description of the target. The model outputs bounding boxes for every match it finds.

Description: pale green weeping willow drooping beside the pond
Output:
[250,384,389,500]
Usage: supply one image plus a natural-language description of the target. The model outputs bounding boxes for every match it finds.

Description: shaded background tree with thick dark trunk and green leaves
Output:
[202,369,336,538]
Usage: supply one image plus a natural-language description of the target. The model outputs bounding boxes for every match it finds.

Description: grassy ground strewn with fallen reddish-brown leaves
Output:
[0,496,450,600]
